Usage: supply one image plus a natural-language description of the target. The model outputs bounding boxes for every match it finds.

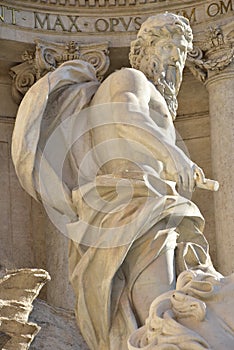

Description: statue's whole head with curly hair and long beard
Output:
[129,13,192,119]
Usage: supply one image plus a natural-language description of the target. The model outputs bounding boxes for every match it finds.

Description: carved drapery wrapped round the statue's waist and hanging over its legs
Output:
[68,175,211,350]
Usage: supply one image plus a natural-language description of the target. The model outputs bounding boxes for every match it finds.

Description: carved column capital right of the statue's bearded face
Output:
[186,27,234,83]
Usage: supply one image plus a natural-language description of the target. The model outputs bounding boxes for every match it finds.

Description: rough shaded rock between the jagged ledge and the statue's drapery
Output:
[30,299,88,350]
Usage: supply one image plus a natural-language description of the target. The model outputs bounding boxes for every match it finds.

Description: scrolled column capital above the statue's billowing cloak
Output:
[10,39,109,103]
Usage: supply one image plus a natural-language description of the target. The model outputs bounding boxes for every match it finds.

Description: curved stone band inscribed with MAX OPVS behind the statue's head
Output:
[0,0,234,33]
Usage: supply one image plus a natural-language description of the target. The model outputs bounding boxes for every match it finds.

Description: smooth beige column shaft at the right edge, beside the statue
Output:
[207,64,234,275]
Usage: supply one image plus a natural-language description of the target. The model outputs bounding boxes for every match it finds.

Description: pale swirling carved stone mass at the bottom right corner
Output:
[128,271,234,350]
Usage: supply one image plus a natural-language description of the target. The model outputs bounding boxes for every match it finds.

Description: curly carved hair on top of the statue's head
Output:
[129,12,193,69]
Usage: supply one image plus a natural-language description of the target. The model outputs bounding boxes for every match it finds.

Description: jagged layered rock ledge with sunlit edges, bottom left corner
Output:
[0,269,50,350]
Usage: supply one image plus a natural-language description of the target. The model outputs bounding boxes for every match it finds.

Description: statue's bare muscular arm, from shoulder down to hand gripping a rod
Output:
[109,68,198,191]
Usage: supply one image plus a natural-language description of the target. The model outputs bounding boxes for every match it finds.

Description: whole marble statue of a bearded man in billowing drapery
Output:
[13,13,233,350]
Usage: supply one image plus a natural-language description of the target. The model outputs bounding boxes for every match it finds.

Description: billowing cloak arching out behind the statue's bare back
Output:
[12,60,100,220]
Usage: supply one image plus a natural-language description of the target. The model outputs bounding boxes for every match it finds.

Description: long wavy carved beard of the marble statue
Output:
[140,56,182,120]
